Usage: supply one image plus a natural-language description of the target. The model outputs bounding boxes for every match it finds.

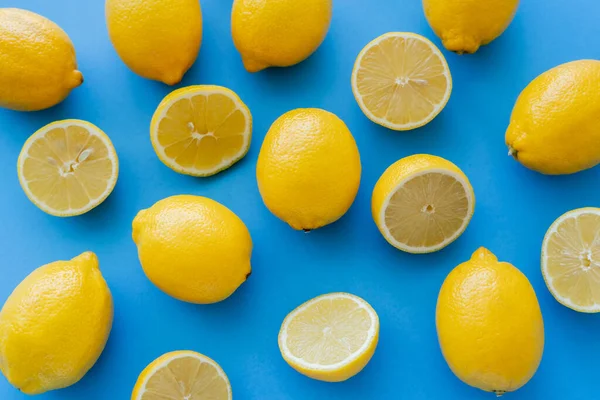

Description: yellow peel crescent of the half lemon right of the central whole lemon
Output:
[371,154,475,251]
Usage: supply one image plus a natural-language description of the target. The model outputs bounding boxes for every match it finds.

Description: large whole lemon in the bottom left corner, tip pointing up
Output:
[0,252,113,394]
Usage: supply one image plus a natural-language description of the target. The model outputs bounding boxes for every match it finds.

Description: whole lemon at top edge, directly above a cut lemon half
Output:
[106,0,202,85]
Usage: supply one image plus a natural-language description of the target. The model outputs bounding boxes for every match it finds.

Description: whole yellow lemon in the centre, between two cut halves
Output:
[256,108,361,230]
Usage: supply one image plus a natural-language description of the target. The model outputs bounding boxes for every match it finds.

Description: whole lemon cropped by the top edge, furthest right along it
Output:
[423,0,519,53]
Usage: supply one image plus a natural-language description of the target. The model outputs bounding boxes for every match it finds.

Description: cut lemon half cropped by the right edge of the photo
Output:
[542,207,600,313]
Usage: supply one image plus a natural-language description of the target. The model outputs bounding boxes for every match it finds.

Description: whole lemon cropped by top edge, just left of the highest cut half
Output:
[231,0,333,72]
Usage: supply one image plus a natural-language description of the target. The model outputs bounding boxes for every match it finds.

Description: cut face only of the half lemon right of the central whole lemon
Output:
[383,171,472,252]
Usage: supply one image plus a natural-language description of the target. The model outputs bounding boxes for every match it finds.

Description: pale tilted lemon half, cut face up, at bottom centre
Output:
[279,293,379,382]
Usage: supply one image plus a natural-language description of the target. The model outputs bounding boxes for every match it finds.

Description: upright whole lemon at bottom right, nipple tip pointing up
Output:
[436,247,544,395]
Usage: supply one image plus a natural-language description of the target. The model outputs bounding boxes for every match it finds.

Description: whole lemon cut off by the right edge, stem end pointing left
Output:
[506,60,600,175]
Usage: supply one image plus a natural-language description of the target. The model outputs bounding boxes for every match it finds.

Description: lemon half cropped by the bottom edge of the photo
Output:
[131,350,232,400]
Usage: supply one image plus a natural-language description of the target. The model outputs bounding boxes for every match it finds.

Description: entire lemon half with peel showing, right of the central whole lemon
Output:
[371,154,475,253]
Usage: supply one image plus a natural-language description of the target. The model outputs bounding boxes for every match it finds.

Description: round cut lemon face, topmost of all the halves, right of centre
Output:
[352,32,452,131]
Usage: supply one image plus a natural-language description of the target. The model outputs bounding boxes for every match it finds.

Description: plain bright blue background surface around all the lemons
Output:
[0,0,600,400]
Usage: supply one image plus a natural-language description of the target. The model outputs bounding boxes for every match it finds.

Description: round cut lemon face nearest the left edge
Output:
[17,119,119,217]
